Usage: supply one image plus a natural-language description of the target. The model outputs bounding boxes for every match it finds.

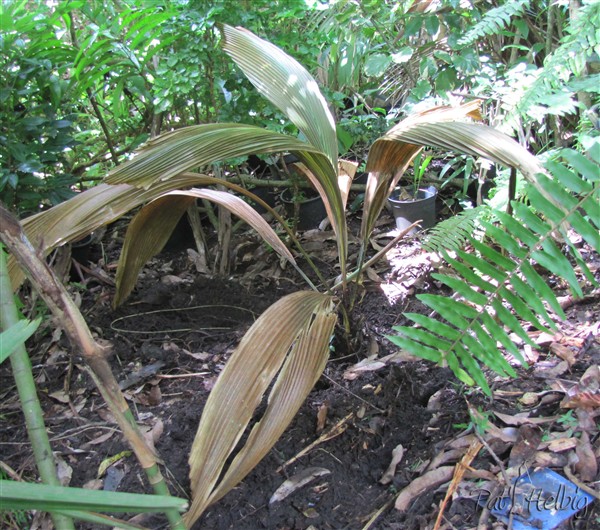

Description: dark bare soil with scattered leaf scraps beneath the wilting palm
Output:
[0,195,600,530]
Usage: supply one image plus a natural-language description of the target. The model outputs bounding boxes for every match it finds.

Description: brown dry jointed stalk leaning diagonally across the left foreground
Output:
[0,205,185,530]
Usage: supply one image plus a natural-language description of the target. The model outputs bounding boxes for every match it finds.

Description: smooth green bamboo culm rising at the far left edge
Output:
[0,244,75,530]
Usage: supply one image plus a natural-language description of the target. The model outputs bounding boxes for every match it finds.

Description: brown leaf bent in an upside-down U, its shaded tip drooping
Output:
[113,189,295,307]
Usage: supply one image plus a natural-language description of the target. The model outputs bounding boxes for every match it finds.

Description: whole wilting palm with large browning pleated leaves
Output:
[3,22,587,527]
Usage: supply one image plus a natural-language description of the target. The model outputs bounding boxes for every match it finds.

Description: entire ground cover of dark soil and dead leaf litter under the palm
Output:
[0,209,600,530]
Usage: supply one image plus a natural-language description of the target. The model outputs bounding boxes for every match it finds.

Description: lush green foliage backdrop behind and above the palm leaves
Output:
[0,0,600,213]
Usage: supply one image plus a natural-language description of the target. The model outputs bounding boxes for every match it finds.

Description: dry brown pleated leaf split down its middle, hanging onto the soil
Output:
[185,292,336,527]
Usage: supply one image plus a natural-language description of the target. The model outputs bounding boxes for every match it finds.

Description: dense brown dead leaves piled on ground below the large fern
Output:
[344,308,600,528]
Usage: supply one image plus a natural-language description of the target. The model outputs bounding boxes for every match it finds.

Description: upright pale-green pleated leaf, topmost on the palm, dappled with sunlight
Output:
[221,25,338,168]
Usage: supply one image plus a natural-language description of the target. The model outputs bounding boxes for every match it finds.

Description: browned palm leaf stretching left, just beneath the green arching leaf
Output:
[8,173,215,288]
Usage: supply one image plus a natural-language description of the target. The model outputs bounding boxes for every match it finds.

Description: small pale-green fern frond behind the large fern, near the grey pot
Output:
[423,205,489,252]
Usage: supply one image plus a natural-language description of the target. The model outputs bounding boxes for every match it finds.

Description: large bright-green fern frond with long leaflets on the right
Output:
[389,150,600,394]
